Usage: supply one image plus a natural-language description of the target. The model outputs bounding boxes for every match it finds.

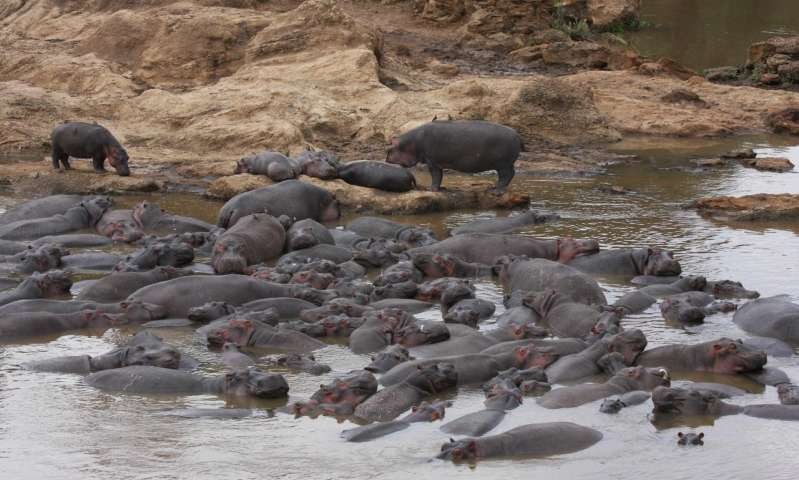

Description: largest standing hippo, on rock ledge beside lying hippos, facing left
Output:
[386,120,524,193]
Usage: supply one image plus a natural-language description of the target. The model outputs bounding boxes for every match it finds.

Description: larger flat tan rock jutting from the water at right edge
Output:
[689,193,799,221]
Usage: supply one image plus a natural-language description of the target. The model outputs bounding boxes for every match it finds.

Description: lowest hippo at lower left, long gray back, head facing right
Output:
[85,366,289,398]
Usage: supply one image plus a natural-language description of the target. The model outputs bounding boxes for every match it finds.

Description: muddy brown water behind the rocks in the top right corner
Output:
[629,0,799,70]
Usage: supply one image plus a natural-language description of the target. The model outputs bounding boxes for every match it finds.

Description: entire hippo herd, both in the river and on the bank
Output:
[0,121,799,462]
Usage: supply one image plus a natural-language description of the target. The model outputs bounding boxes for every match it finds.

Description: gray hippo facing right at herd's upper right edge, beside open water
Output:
[569,248,682,277]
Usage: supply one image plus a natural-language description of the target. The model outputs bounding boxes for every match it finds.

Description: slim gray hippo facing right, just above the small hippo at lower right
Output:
[538,366,671,408]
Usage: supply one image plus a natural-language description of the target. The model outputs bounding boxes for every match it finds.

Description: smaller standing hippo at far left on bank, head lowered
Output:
[50,122,130,177]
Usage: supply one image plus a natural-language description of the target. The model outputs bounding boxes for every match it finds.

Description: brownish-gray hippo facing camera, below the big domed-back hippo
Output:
[211,213,286,274]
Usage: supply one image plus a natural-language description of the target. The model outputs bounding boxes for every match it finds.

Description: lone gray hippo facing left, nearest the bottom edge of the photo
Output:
[436,422,602,463]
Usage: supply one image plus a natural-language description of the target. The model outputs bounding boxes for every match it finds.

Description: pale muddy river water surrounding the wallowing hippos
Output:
[0,137,799,480]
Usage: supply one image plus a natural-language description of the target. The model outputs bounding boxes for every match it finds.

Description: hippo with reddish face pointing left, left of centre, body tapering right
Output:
[206,316,326,352]
